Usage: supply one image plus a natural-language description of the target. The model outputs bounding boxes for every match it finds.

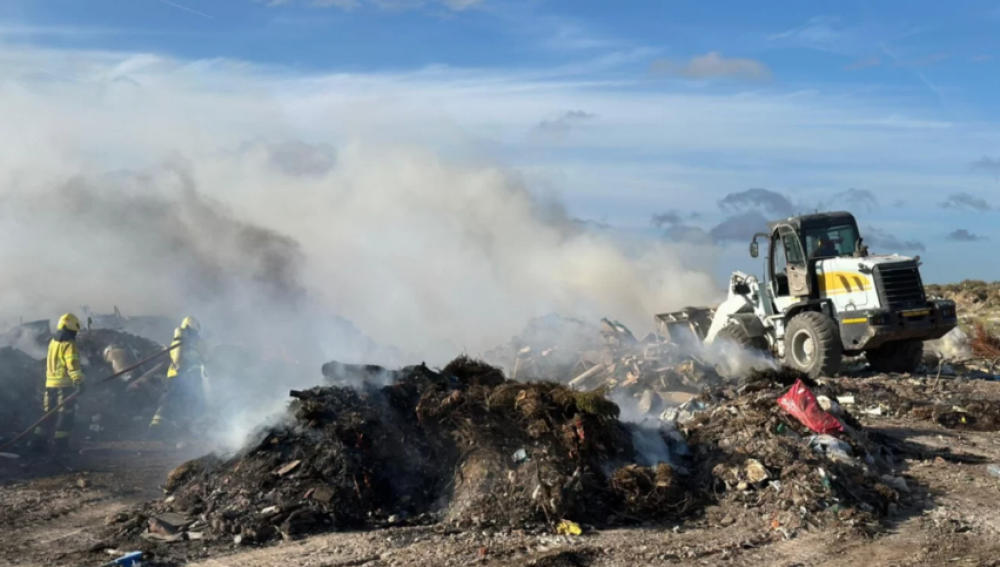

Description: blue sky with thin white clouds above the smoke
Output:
[0,0,1000,281]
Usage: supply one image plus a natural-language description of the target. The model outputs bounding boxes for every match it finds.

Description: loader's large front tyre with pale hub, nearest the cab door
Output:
[785,311,843,380]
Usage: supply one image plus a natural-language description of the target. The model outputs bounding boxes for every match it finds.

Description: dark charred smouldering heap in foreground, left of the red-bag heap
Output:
[105,357,690,552]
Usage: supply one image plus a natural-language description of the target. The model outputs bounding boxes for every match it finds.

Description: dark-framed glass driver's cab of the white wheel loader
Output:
[767,212,860,312]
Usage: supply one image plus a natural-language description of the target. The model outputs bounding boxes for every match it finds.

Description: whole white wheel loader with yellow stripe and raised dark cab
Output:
[656,211,958,378]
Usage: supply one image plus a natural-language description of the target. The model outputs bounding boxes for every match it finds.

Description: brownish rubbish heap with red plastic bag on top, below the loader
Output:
[682,369,909,535]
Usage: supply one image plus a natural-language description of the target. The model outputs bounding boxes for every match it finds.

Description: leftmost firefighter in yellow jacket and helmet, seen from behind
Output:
[32,313,84,449]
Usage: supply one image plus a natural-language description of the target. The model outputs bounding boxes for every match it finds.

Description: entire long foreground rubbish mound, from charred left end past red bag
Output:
[101,357,908,556]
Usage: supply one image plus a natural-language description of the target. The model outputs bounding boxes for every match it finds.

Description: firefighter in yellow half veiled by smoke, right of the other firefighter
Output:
[149,317,207,436]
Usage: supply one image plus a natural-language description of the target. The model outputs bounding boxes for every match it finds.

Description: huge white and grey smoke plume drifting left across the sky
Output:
[0,45,717,448]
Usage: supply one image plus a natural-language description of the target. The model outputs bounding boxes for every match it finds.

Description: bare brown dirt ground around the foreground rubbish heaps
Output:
[0,376,1000,567]
